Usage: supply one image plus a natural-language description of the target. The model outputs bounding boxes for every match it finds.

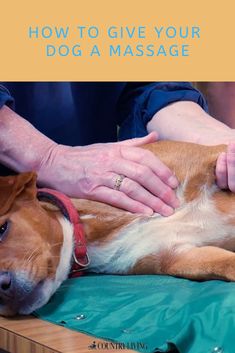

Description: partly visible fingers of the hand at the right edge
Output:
[215,142,235,192]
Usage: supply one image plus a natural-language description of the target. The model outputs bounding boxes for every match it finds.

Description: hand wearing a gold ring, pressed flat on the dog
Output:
[37,133,178,216]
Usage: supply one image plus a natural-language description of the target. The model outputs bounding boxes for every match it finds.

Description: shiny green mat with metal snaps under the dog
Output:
[35,275,235,353]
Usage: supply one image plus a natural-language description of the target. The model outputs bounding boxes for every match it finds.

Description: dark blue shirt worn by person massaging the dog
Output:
[0,82,206,146]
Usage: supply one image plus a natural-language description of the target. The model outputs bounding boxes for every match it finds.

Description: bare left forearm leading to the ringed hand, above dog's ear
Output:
[0,106,56,172]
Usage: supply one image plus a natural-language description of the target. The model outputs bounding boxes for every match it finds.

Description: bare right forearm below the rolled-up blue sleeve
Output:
[147,101,234,145]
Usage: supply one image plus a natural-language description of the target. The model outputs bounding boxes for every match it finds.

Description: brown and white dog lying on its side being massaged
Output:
[0,141,235,316]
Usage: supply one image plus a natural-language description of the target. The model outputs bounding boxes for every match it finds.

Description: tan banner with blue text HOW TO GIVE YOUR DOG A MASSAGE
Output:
[0,0,235,81]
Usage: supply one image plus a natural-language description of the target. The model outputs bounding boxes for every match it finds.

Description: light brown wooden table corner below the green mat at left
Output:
[0,316,133,353]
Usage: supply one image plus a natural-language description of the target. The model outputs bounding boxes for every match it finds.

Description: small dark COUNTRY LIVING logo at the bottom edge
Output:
[88,341,148,351]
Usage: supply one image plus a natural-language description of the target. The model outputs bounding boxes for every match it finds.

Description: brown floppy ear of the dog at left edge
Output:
[0,172,37,216]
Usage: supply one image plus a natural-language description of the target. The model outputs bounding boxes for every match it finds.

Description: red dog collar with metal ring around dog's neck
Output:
[37,188,90,277]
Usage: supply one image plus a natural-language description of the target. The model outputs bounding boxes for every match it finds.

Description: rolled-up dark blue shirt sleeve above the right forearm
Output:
[118,82,208,140]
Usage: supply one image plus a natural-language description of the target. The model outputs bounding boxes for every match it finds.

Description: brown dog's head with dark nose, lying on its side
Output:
[0,173,63,316]
